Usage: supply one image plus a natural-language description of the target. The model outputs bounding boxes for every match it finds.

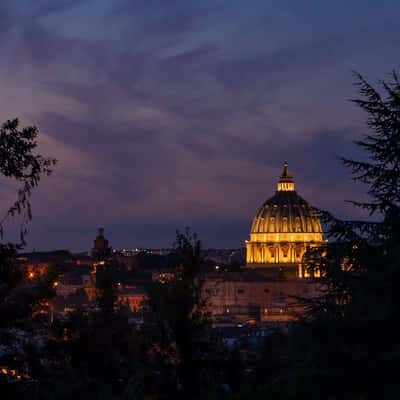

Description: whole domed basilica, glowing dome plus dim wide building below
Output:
[204,162,325,324]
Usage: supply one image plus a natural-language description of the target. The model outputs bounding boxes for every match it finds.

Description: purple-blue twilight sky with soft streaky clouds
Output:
[0,0,400,250]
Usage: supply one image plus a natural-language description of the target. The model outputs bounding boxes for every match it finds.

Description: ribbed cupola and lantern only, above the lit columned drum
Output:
[251,162,322,234]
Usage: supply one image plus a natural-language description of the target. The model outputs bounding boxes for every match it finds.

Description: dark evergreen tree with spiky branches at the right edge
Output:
[292,72,400,399]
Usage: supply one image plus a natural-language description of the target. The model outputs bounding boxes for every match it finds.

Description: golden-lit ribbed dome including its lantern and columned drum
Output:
[246,162,324,277]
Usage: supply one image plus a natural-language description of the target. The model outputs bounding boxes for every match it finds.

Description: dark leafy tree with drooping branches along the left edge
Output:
[0,119,56,398]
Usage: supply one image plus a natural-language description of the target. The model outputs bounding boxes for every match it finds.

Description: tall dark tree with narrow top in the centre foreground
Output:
[146,230,219,399]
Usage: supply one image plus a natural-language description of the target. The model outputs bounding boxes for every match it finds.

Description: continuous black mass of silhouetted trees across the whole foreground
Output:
[0,73,400,400]
